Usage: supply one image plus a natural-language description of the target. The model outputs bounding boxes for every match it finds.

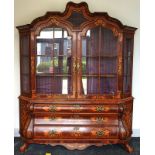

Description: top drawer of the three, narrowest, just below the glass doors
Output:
[33,103,122,113]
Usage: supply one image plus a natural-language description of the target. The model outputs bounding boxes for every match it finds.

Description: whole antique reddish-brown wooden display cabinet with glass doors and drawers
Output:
[17,2,136,152]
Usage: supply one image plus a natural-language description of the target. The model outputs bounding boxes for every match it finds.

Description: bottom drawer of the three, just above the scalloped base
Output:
[34,125,119,139]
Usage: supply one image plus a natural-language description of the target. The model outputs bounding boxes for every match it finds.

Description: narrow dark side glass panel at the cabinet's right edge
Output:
[123,38,133,93]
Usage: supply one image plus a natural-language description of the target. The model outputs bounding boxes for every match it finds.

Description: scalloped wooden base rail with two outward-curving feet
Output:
[20,138,133,153]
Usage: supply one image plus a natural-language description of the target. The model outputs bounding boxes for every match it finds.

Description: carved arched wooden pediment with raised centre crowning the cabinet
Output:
[18,2,136,34]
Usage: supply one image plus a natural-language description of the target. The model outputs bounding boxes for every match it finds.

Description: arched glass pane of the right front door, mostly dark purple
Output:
[82,27,117,95]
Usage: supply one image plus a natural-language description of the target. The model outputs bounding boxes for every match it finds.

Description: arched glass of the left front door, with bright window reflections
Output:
[36,28,72,94]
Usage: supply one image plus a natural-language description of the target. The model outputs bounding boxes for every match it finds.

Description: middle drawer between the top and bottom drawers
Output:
[34,113,118,126]
